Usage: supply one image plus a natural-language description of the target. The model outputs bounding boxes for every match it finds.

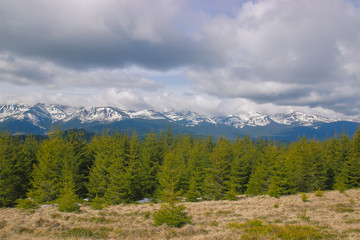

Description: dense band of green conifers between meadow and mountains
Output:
[0,125,360,207]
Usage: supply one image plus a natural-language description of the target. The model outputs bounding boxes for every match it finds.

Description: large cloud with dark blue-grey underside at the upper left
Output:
[0,0,225,70]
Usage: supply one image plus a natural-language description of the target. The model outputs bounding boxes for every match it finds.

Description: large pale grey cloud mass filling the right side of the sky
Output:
[188,0,360,114]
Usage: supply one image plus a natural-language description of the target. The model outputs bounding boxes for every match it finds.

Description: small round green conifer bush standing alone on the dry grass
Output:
[153,203,192,228]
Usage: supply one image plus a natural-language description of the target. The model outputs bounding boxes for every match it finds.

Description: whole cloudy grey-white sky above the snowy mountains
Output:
[0,0,360,119]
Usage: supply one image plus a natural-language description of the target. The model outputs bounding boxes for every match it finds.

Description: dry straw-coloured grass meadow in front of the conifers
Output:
[0,190,360,240]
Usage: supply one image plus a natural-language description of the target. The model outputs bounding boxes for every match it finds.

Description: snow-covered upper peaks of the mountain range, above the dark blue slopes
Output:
[0,103,334,128]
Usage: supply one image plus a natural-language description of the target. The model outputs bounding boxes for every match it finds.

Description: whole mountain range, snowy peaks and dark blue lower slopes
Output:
[0,103,360,141]
